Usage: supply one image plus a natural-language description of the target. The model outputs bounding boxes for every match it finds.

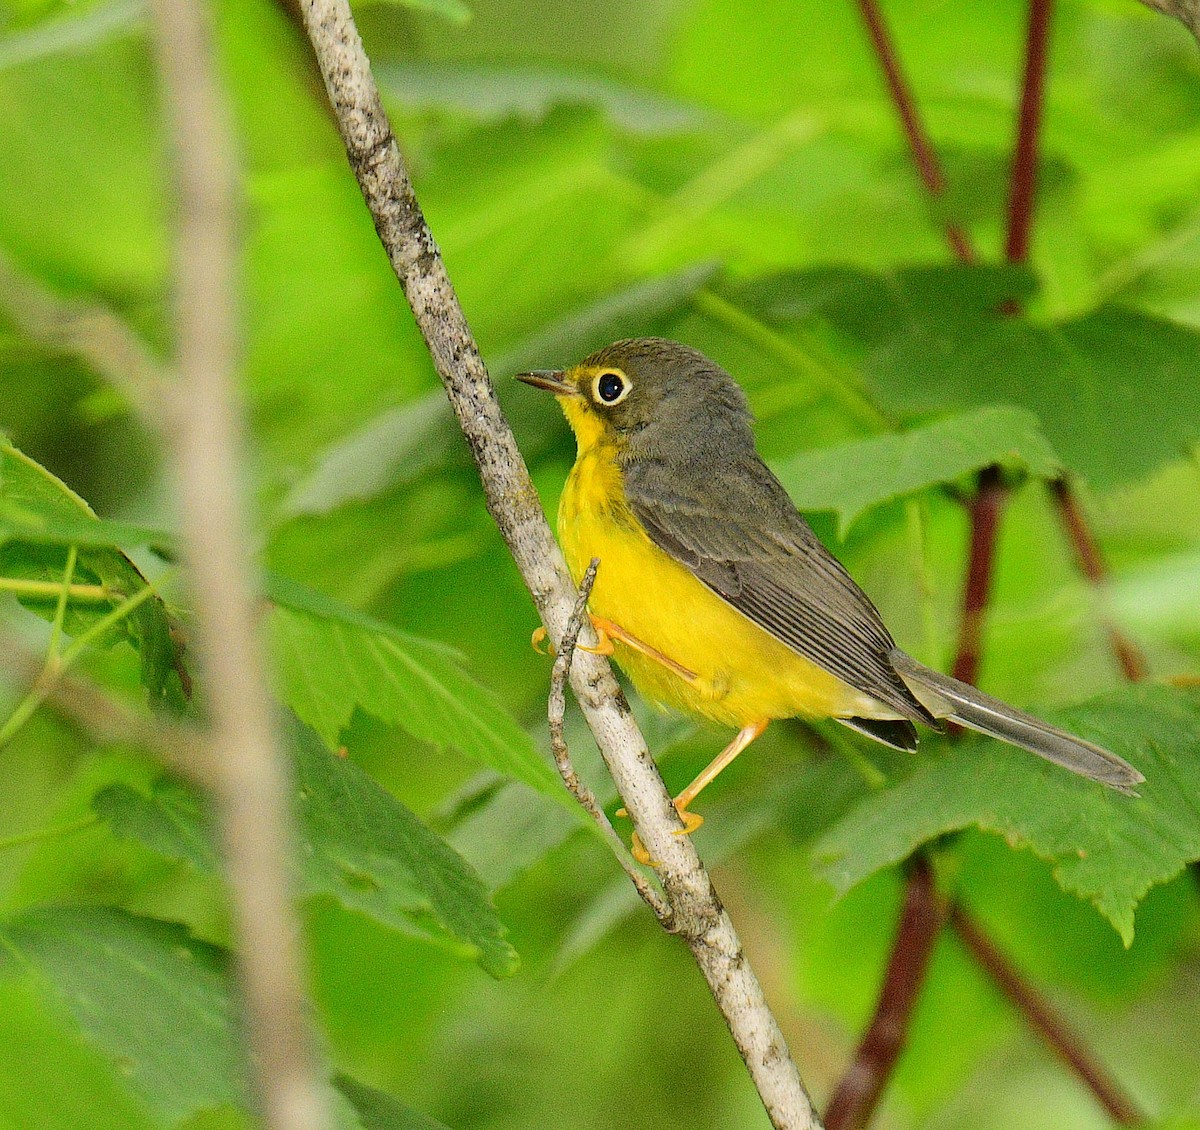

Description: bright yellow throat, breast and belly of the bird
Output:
[558,449,890,726]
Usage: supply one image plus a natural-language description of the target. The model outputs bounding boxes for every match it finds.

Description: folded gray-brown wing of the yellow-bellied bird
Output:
[623,453,937,726]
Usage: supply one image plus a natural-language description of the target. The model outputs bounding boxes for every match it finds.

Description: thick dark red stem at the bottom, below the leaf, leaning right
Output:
[826,855,946,1130]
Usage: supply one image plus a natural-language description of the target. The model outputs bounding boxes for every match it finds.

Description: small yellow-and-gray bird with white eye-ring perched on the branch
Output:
[518,337,1144,831]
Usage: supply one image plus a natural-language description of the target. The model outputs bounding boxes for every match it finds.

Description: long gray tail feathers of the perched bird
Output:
[890,649,1146,797]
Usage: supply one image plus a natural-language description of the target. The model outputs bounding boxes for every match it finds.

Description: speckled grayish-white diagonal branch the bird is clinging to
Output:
[302,0,820,1130]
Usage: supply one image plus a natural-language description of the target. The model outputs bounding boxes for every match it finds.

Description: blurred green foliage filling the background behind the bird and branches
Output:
[0,0,1200,1130]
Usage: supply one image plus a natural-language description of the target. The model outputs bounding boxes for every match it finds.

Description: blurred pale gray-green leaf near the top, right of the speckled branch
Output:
[376,59,709,134]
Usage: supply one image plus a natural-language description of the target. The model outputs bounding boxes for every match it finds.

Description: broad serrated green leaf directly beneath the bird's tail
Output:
[815,685,1200,945]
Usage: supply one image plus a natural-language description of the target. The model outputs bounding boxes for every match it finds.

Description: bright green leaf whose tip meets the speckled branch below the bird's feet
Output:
[268,576,566,803]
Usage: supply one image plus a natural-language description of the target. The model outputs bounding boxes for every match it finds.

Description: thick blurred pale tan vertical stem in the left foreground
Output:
[154,0,326,1130]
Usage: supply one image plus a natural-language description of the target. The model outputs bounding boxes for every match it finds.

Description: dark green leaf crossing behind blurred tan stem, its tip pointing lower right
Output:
[94,727,517,976]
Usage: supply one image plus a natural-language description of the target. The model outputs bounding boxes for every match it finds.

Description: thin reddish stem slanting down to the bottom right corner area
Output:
[949,906,1146,1126]
